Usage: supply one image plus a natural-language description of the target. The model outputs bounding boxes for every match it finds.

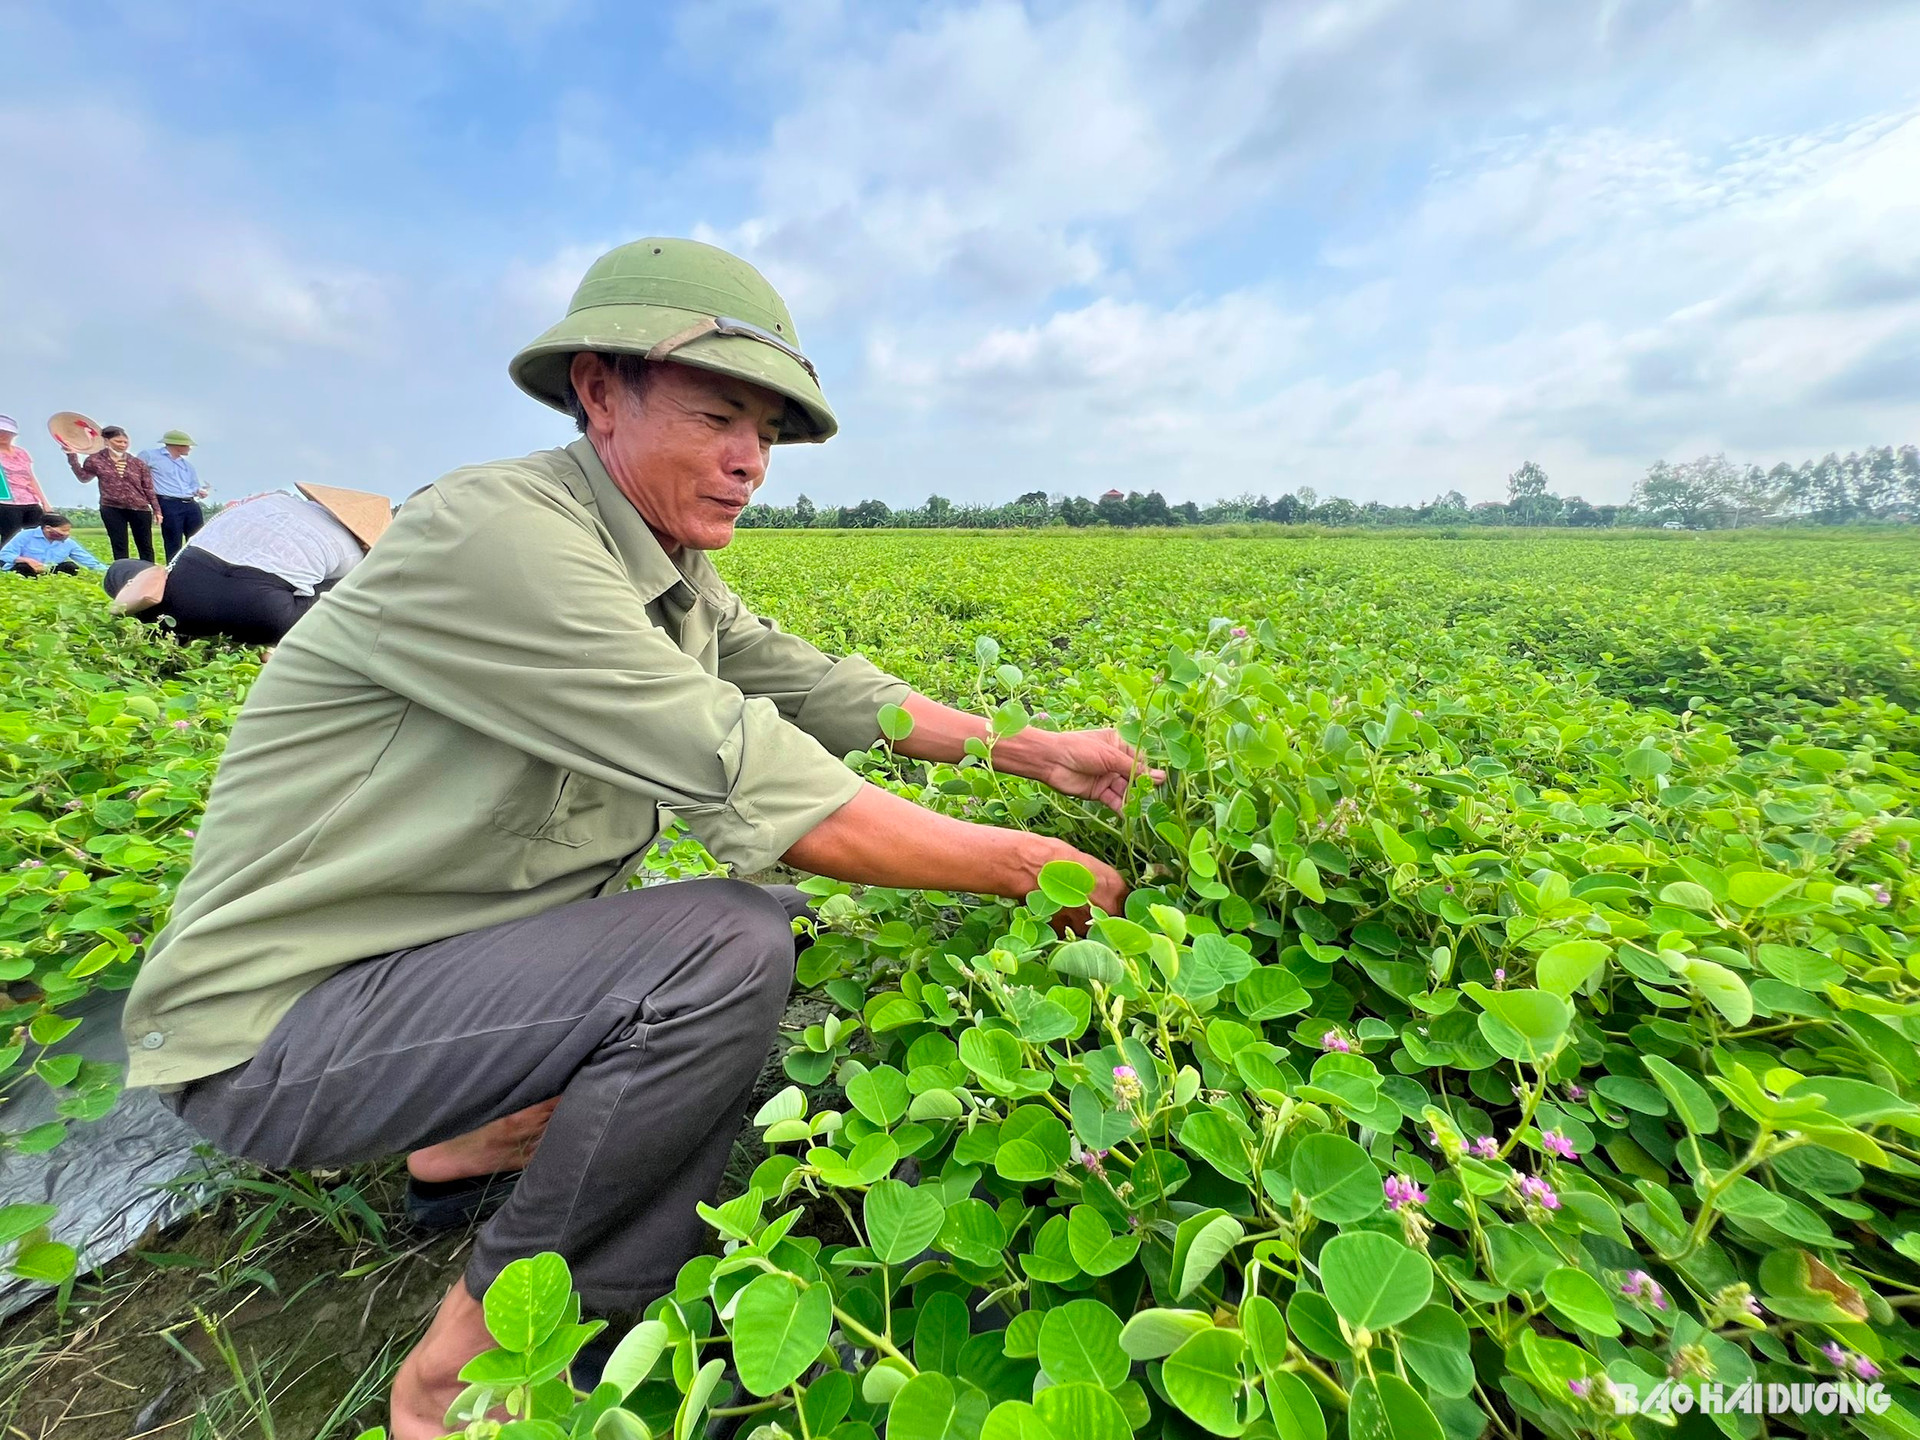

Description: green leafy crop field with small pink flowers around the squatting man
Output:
[0,530,1920,1440]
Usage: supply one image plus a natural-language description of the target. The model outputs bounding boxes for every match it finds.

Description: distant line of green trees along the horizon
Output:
[739,445,1920,530]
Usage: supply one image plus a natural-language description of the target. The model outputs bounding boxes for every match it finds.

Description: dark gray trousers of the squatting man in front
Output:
[157,879,806,1313]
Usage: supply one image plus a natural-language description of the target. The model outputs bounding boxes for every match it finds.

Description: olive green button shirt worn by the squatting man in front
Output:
[125,440,908,1085]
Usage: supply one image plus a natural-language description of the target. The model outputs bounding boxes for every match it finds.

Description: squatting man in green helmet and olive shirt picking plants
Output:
[125,240,1140,1440]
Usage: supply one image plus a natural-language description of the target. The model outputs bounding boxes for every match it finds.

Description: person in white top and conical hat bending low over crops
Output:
[102,486,394,645]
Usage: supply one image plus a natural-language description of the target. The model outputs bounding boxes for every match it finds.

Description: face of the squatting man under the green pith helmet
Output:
[572,355,787,553]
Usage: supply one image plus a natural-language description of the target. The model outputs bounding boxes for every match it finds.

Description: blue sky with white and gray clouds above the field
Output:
[0,0,1920,505]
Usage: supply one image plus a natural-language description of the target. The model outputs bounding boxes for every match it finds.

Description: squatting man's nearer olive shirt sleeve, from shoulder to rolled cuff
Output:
[355,480,860,874]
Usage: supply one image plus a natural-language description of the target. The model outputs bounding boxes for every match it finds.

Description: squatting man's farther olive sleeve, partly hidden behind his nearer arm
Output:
[720,599,912,755]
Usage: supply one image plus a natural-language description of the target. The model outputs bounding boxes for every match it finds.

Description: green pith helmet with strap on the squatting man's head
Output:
[507,240,839,442]
